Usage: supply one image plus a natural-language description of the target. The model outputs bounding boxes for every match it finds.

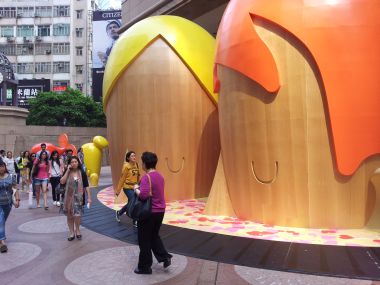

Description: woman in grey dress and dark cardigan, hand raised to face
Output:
[60,156,92,241]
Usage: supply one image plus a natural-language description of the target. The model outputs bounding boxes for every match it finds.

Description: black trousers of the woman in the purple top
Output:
[137,213,172,270]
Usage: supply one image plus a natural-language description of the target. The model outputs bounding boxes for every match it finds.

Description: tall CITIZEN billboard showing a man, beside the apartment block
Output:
[92,10,121,101]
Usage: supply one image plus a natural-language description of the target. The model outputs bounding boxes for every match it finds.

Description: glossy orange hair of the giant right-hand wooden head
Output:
[216,0,380,175]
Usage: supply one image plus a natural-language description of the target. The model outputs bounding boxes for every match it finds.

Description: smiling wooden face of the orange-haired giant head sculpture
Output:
[218,24,380,228]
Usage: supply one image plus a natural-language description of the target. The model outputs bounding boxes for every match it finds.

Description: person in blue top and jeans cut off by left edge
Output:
[0,158,20,253]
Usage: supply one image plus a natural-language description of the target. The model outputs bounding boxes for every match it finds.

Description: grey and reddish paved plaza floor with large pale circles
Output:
[0,167,380,285]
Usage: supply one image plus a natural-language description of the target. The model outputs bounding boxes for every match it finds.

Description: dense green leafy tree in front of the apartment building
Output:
[26,88,106,127]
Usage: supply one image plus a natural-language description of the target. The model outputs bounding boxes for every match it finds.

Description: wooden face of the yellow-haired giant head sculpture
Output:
[106,39,220,200]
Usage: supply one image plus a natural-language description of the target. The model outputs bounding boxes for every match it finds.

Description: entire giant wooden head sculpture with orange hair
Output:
[208,0,380,228]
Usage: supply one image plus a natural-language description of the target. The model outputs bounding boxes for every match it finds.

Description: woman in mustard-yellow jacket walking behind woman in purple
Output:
[115,150,140,227]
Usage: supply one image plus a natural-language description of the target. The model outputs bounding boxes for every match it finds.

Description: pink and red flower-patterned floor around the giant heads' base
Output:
[98,187,380,247]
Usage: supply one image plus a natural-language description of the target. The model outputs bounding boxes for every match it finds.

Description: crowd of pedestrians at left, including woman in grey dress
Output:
[0,143,87,250]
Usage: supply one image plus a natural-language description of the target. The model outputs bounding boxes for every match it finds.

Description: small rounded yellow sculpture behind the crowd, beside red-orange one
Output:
[82,136,108,186]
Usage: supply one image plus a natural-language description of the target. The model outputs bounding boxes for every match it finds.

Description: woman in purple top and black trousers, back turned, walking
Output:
[134,152,172,274]
